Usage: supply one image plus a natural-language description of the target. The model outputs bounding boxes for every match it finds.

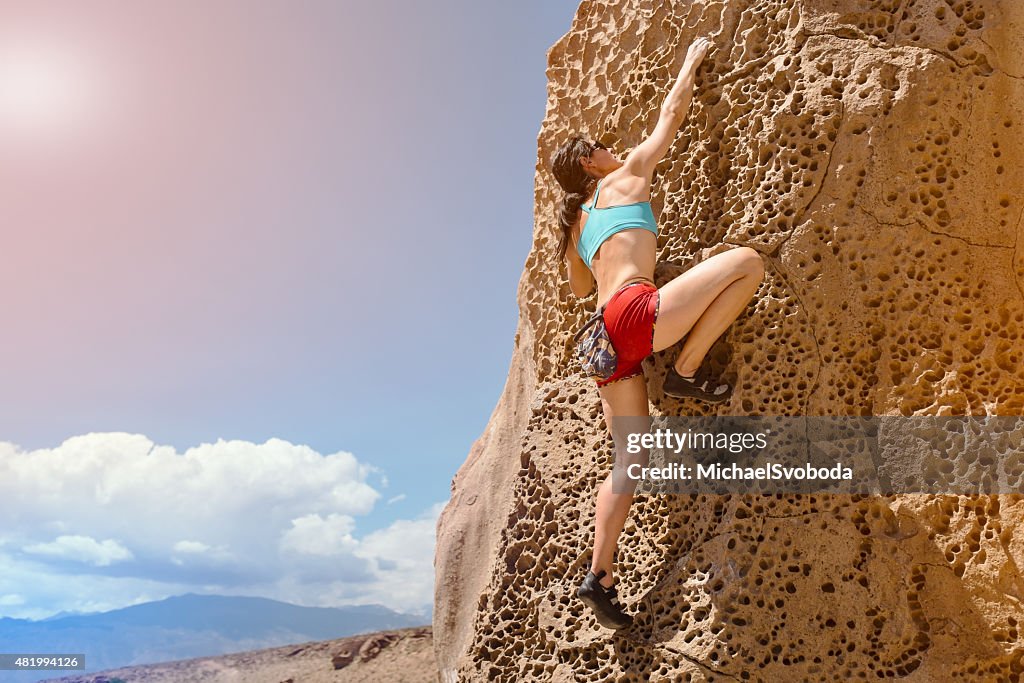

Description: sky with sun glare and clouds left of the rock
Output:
[0,0,577,618]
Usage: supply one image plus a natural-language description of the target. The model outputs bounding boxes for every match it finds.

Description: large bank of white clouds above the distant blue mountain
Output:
[0,432,439,618]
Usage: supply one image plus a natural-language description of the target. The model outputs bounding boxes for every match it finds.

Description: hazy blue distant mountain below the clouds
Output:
[0,593,430,683]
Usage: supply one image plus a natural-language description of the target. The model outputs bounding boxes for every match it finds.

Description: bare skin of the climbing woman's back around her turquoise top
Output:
[574,171,657,306]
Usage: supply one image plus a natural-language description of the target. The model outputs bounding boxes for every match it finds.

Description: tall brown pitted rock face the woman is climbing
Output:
[434,0,1024,682]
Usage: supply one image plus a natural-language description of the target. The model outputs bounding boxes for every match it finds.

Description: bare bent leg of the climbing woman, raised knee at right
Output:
[654,247,765,377]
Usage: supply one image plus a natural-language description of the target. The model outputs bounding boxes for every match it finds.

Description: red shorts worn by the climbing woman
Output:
[597,282,660,387]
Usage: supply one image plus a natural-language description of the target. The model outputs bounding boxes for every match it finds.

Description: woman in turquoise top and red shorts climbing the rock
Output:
[552,38,764,629]
